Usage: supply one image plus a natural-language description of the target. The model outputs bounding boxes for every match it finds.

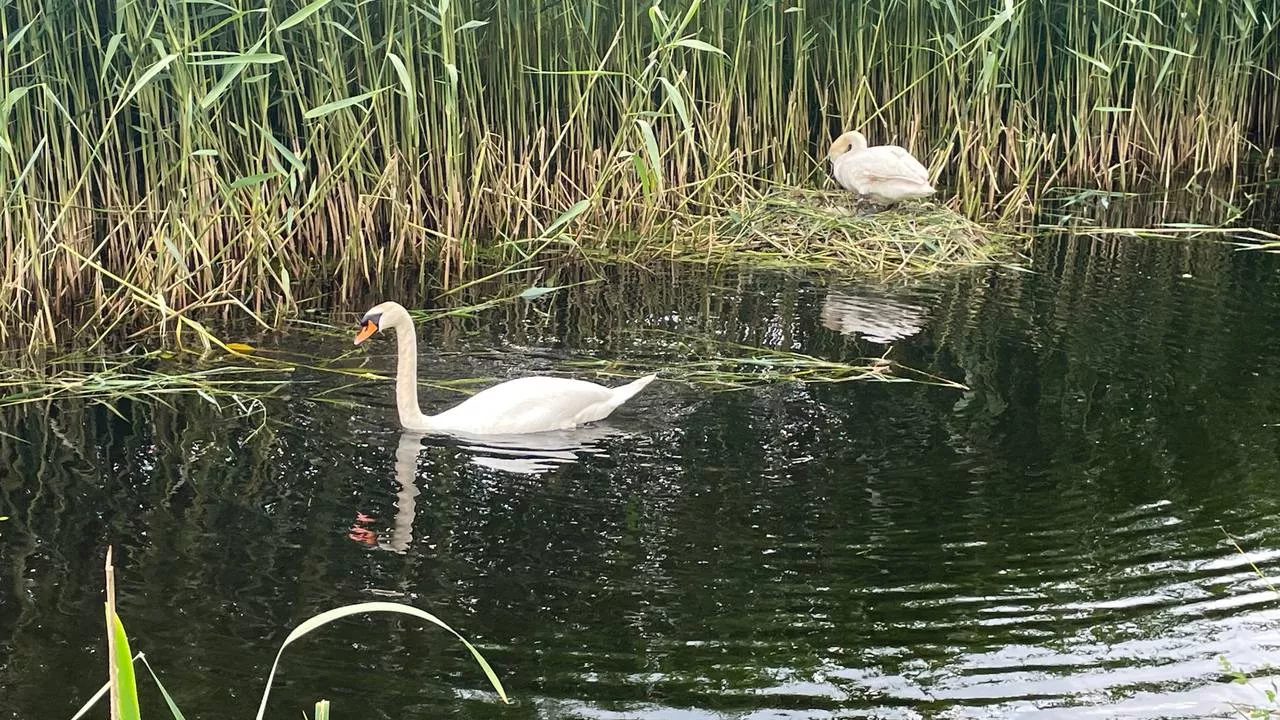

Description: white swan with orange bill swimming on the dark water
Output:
[356,302,657,436]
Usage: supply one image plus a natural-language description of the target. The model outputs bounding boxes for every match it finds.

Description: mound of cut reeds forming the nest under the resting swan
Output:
[671,188,1009,274]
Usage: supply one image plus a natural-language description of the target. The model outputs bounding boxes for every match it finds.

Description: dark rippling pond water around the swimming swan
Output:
[0,237,1280,720]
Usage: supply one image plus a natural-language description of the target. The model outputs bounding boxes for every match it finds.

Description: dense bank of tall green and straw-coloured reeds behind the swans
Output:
[0,0,1280,345]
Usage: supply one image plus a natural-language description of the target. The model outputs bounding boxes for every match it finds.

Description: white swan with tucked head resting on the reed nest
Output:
[827,129,934,205]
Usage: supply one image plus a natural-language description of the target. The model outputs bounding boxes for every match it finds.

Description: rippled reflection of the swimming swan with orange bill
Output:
[348,423,625,552]
